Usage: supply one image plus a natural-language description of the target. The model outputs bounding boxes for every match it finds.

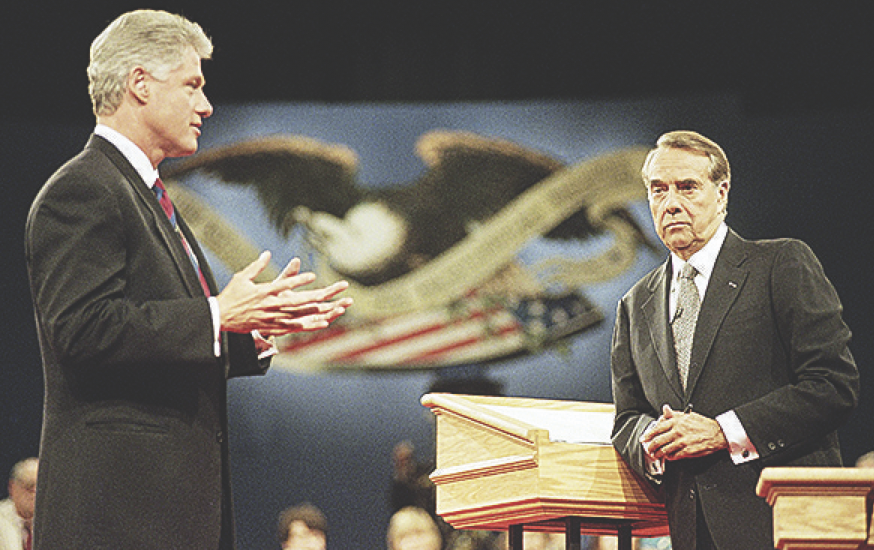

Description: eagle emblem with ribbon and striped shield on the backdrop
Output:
[164,130,656,370]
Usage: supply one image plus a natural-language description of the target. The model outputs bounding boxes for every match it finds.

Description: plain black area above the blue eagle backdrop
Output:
[6,0,874,120]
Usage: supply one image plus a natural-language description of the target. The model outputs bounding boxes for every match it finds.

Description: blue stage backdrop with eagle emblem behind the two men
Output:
[2,96,874,550]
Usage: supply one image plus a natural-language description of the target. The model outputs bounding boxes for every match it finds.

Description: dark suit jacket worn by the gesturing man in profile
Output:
[26,136,266,550]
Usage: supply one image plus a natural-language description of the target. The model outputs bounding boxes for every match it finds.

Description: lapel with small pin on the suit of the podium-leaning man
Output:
[686,230,749,398]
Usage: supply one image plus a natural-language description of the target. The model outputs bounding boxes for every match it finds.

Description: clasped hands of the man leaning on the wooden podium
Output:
[640,405,728,460]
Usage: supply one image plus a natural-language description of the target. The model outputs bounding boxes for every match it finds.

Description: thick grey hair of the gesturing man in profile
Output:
[88,10,212,116]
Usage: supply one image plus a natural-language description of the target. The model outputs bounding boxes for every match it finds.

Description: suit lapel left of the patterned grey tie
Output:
[641,261,683,399]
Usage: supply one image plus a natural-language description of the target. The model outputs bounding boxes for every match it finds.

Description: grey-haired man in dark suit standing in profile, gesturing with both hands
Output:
[26,11,351,550]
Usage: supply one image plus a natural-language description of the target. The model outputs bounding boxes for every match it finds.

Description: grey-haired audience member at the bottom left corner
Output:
[0,458,39,550]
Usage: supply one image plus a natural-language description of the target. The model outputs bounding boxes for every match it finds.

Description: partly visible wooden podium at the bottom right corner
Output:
[756,467,874,550]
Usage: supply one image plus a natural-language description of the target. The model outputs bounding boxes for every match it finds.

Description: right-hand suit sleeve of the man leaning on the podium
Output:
[735,241,859,464]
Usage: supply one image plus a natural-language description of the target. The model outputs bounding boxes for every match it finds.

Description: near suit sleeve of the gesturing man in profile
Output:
[26,164,216,374]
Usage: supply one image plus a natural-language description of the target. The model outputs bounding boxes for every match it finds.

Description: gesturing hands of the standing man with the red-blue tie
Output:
[216,251,352,337]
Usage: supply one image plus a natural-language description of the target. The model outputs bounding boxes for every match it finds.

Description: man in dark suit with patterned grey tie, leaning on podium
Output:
[612,132,859,550]
